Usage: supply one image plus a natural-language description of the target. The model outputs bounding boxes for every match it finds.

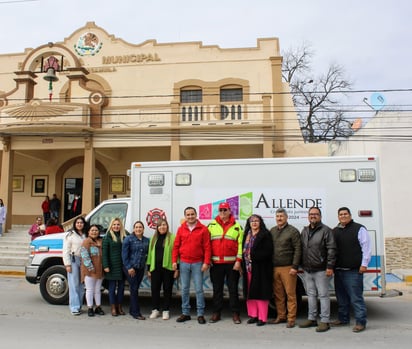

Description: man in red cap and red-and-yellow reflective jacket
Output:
[208,202,243,324]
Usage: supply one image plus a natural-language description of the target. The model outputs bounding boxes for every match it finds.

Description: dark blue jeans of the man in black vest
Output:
[335,269,366,326]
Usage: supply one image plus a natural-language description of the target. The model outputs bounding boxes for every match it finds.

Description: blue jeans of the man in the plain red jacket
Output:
[180,262,205,316]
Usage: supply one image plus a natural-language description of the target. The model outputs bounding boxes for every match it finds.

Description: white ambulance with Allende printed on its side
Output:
[26,156,386,303]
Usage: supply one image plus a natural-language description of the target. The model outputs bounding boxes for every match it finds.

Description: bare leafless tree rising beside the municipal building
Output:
[282,45,352,143]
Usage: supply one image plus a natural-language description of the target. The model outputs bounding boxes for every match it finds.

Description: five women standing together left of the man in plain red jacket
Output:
[63,217,177,320]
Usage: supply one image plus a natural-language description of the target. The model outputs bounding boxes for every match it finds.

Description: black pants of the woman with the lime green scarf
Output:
[151,268,174,310]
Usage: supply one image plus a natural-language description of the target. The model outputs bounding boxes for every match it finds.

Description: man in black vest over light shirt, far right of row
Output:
[332,207,372,333]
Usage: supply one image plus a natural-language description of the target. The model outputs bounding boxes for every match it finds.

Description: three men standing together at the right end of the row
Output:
[271,207,371,332]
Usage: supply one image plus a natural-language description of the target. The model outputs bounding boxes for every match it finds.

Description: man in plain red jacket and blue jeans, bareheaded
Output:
[172,207,211,325]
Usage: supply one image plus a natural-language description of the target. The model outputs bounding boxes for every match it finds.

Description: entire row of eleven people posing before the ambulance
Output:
[63,202,371,332]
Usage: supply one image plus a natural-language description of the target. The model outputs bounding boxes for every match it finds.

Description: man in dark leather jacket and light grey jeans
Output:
[299,207,336,332]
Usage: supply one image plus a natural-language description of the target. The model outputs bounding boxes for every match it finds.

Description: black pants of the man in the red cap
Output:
[210,263,240,314]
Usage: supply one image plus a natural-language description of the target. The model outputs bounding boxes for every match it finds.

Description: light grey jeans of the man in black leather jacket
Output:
[304,270,330,323]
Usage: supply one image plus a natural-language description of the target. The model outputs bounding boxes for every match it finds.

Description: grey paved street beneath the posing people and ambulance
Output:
[0,276,412,349]
